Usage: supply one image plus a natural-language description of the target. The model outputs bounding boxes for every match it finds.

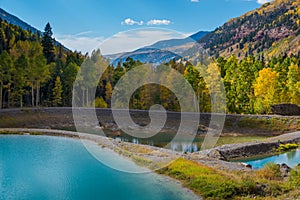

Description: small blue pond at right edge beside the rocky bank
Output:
[245,150,300,169]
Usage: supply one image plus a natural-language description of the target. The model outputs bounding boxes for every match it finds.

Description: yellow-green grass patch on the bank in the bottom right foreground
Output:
[158,159,300,199]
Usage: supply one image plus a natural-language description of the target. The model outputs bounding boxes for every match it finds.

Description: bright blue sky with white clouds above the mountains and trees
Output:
[0,0,268,53]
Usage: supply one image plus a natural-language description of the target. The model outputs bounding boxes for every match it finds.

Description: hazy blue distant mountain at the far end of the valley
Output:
[106,31,209,66]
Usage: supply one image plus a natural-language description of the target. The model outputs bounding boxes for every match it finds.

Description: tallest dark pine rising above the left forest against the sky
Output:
[42,22,55,64]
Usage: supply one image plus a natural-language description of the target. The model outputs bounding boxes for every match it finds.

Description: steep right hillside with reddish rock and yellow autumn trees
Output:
[193,0,300,58]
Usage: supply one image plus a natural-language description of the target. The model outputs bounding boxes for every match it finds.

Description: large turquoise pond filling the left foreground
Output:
[0,136,195,200]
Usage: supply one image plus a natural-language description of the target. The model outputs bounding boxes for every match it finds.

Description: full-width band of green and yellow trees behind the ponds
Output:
[0,18,300,114]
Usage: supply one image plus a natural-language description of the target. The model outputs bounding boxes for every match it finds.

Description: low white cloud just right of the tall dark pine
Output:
[55,31,104,53]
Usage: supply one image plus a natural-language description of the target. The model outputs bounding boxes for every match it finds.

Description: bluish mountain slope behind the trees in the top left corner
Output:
[0,8,40,33]
